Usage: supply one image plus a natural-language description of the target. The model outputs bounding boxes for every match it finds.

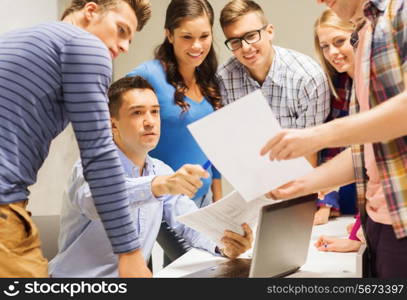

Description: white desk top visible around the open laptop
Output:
[154,216,358,278]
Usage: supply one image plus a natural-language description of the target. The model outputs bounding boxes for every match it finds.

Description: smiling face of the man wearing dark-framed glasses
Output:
[223,12,273,78]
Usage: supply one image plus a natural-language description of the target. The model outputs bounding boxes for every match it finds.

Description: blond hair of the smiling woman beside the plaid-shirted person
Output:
[314,8,355,97]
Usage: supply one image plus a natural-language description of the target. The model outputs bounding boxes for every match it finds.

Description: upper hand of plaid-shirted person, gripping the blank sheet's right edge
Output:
[260,127,321,160]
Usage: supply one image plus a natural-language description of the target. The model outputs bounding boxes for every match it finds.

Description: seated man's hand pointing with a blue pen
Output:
[151,165,209,198]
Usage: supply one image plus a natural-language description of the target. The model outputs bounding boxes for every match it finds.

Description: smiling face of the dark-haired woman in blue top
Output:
[166,15,212,68]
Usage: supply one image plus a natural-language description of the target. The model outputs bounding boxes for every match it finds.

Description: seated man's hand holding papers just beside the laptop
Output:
[221,223,253,259]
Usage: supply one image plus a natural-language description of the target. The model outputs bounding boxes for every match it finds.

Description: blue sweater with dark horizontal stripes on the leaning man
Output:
[0,22,140,253]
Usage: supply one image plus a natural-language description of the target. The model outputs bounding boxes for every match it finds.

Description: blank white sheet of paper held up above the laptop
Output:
[188,90,312,201]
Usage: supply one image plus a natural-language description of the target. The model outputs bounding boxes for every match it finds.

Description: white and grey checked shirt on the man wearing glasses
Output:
[217,46,330,128]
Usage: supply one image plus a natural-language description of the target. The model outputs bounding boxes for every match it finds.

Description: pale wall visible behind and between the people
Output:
[0,0,324,215]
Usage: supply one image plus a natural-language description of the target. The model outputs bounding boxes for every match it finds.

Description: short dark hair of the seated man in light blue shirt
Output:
[107,76,155,119]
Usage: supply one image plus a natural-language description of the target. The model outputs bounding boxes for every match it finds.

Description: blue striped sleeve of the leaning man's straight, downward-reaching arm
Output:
[60,33,140,254]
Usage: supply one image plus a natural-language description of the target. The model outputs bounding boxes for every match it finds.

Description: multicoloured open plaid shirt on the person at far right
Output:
[350,0,407,238]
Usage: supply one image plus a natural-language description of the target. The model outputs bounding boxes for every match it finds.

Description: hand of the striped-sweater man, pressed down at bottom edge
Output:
[119,249,153,278]
